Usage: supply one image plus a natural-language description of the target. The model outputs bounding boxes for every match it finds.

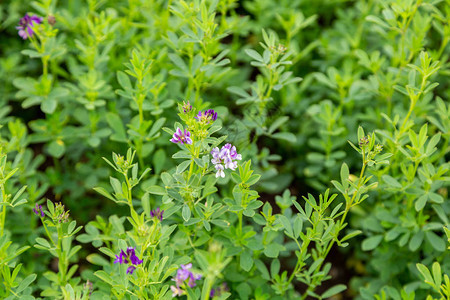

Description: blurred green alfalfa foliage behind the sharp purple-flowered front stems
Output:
[0,0,450,299]
